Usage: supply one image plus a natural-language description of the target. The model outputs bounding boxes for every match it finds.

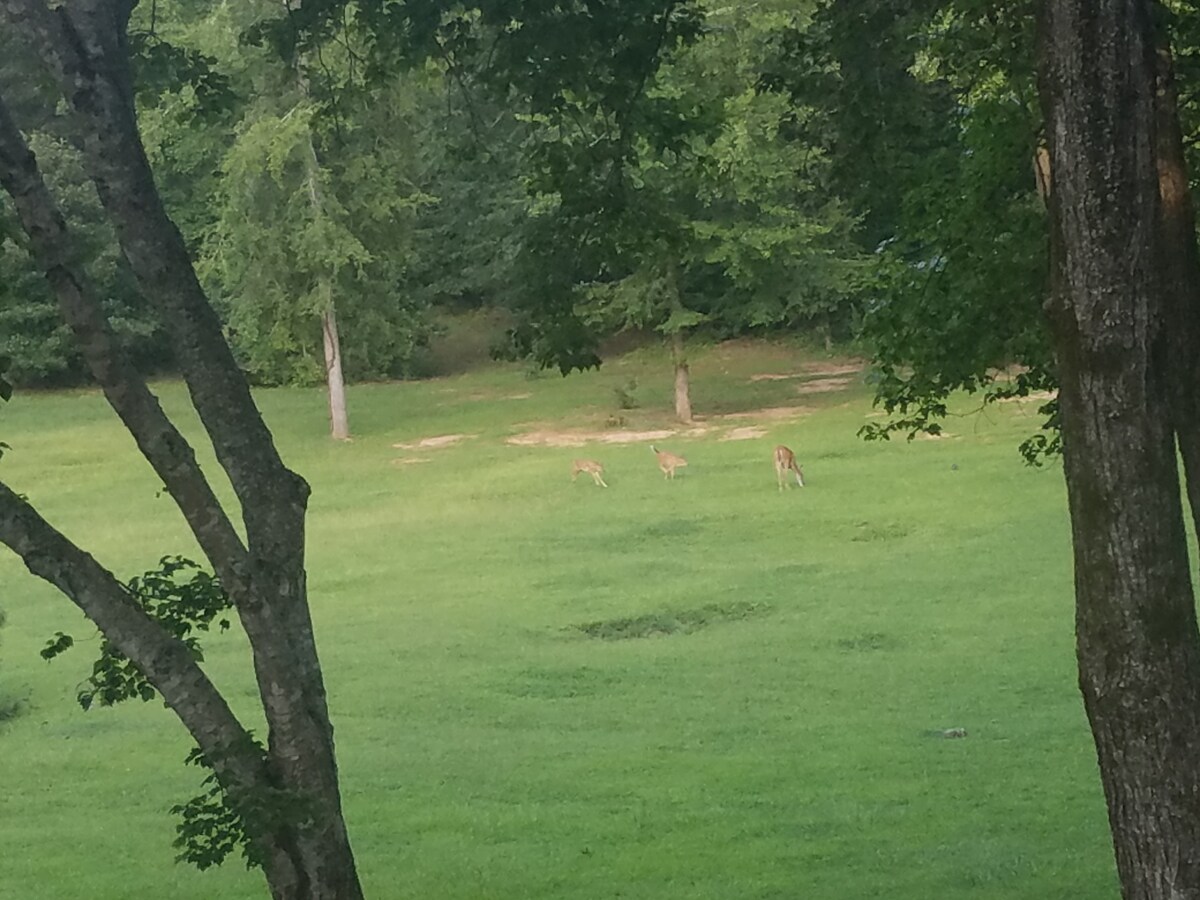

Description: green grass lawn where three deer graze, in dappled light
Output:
[0,344,1118,900]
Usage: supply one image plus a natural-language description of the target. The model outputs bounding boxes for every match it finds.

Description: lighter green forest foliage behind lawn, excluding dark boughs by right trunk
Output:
[0,0,866,393]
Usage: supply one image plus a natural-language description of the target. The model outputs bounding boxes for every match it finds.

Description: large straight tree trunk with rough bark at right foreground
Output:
[1039,0,1200,900]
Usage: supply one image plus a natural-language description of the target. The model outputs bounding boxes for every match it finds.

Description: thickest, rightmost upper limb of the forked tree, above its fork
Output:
[0,0,308,564]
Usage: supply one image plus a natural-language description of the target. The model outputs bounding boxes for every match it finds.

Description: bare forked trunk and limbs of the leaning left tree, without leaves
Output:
[0,0,362,900]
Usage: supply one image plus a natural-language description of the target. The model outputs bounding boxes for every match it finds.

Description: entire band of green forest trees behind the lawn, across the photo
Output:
[0,0,1200,426]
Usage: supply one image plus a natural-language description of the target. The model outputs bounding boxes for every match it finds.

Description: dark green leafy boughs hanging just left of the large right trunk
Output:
[785,0,1057,460]
